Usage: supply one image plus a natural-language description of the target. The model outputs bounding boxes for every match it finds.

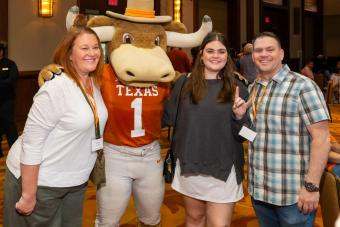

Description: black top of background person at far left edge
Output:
[0,58,19,99]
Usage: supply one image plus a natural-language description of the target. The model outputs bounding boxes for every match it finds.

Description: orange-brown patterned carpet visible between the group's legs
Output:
[0,104,340,227]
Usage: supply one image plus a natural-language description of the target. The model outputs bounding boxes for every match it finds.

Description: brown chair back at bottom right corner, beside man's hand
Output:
[320,170,340,227]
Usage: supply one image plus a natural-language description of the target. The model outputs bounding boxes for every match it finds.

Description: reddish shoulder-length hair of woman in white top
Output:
[53,26,103,86]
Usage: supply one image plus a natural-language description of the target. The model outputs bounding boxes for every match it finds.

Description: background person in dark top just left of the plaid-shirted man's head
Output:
[240,43,258,83]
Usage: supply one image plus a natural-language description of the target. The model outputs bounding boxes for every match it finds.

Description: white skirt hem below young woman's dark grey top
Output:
[171,160,243,203]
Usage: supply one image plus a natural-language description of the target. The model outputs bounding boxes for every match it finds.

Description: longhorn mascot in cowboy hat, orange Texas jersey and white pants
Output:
[41,0,212,227]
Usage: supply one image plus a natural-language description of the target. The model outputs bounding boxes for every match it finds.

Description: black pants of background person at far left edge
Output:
[0,97,18,152]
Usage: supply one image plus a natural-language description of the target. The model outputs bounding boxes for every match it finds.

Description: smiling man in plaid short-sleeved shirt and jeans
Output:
[235,32,330,227]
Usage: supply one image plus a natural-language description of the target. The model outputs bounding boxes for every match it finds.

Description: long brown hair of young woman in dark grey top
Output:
[184,32,235,104]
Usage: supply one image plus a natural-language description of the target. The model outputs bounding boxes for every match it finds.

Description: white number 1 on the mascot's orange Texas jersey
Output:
[131,98,145,138]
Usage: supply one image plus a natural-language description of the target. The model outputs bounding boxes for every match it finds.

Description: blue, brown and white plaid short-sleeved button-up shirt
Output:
[248,65,329,206]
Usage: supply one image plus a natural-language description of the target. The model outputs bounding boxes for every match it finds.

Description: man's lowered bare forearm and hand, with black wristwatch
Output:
[298,121,330,213]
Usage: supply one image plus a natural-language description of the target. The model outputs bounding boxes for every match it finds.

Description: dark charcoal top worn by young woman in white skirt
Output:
[163,76,248,184]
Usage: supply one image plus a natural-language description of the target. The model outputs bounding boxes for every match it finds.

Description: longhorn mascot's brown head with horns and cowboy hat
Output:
[66,0,212,87]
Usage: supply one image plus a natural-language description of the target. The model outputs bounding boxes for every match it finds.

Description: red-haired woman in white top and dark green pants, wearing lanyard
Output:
[3,27,108,227]
